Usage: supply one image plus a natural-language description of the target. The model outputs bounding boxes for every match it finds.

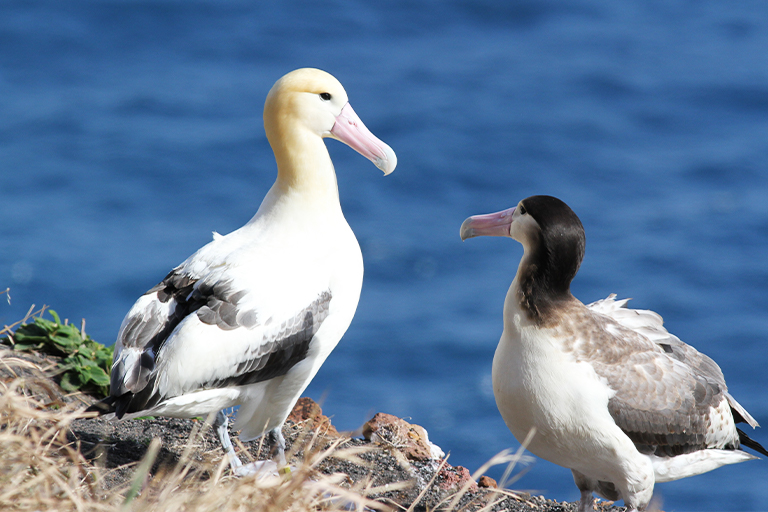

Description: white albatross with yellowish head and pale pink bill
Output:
[91,69,397,475]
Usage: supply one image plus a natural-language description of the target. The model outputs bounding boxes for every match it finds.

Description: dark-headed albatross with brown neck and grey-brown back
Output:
[461,196,768,512]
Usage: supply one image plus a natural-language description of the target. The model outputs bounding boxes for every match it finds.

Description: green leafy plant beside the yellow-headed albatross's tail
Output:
[2,309,113,397]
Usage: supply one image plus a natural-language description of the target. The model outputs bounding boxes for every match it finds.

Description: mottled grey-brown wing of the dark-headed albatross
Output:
[574,306,738,456]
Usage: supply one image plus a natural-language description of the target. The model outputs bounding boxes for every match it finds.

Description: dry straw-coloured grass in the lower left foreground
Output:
[0,372,408,512]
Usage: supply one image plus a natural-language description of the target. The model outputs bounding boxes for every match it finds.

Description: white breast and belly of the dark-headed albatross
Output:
[493,328,652,481]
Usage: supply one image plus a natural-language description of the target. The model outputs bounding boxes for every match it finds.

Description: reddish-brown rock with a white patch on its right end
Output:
[363,412,443,460]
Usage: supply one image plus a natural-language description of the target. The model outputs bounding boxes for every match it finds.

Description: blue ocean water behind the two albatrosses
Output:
[0,0,768,511]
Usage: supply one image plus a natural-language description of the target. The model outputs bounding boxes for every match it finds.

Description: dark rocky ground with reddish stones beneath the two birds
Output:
[0,346,624,512]
